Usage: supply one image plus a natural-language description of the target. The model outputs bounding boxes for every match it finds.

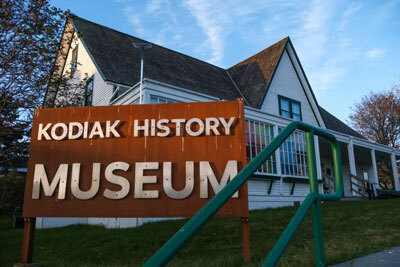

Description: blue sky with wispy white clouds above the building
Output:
[51,0,400,122]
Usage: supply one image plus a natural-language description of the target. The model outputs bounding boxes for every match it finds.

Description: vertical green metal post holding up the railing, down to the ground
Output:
[306,130,325,266]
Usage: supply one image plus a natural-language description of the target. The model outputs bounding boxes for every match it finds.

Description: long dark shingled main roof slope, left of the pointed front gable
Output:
[71,16,241,100]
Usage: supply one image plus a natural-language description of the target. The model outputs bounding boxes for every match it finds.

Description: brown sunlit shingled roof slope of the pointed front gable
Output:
[229,37,289,108]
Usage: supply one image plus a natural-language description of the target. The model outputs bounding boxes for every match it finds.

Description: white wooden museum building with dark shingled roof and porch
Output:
[37,16,400,228]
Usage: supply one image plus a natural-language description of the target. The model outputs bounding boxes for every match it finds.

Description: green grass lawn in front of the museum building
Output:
[0,199,400,266]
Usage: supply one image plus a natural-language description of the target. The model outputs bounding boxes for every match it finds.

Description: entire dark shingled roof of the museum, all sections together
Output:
[71,15,365,139]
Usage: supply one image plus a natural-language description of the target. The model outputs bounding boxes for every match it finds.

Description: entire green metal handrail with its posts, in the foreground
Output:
[144,122,343,266]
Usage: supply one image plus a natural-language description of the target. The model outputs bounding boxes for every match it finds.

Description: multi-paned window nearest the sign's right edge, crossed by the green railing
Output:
[245,120,277,174]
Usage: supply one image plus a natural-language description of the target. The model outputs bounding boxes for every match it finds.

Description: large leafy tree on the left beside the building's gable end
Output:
[0,0,80,172]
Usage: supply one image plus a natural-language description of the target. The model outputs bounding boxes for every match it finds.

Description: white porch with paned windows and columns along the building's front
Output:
[245,108,400,209]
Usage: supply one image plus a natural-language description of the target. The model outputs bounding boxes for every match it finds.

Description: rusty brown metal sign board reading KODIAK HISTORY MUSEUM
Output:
[23,100,248,217]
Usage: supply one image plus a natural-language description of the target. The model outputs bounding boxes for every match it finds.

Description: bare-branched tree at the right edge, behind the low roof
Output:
[350,85,400,148]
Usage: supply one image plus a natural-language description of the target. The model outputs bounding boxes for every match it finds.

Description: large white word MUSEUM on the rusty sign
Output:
[32,160,239,200]
